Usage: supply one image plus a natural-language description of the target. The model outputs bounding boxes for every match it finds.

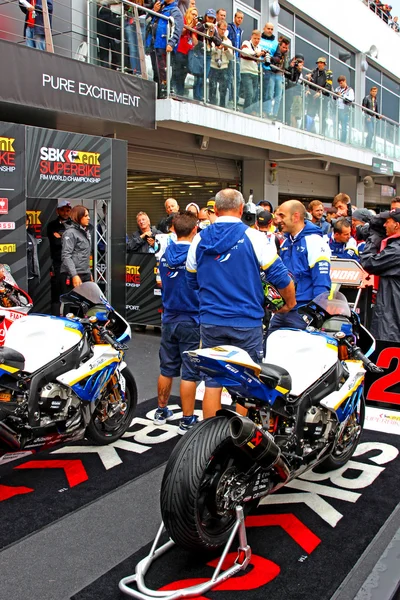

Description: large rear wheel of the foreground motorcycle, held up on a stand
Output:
[161,417,251,551]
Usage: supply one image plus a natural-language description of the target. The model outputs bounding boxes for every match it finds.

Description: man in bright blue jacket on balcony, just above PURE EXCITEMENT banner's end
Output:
[146,0,183,98]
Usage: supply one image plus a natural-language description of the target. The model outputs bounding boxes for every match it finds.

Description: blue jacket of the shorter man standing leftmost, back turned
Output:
[159,242,199,323]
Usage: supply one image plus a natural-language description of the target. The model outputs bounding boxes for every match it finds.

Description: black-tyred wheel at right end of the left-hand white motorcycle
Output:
[85,368,137,446]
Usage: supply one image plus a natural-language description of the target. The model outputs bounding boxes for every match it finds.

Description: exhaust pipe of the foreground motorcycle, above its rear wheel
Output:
[229,415,290,481]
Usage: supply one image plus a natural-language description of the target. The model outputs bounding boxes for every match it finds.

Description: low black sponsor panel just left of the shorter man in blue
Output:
[125,252,162,327]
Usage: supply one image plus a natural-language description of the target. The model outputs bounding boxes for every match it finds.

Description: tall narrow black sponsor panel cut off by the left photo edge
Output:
[0,122,27,289]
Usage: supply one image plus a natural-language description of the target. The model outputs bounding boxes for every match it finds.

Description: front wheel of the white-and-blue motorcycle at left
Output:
[85,367,137,446]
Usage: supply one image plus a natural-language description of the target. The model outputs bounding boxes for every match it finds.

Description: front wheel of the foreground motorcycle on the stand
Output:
[317,395,365,473]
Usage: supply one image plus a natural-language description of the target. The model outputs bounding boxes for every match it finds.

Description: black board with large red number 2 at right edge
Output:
[365,340,400,414]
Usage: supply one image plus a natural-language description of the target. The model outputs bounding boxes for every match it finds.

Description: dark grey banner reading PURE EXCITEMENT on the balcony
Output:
[0,41,156,129]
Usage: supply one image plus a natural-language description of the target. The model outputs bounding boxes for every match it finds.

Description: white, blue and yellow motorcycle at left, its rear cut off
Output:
[0,282,137,464]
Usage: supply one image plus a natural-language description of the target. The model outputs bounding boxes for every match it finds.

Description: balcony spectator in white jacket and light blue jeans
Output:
[240,29,261,115]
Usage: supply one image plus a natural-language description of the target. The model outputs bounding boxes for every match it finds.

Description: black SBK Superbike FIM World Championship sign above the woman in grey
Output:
[26,127,111,199]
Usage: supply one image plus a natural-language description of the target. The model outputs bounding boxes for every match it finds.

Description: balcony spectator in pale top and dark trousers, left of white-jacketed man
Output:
[209,21,233,108]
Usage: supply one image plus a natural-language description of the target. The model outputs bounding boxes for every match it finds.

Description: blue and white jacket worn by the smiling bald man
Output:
[280,221,331,307]
